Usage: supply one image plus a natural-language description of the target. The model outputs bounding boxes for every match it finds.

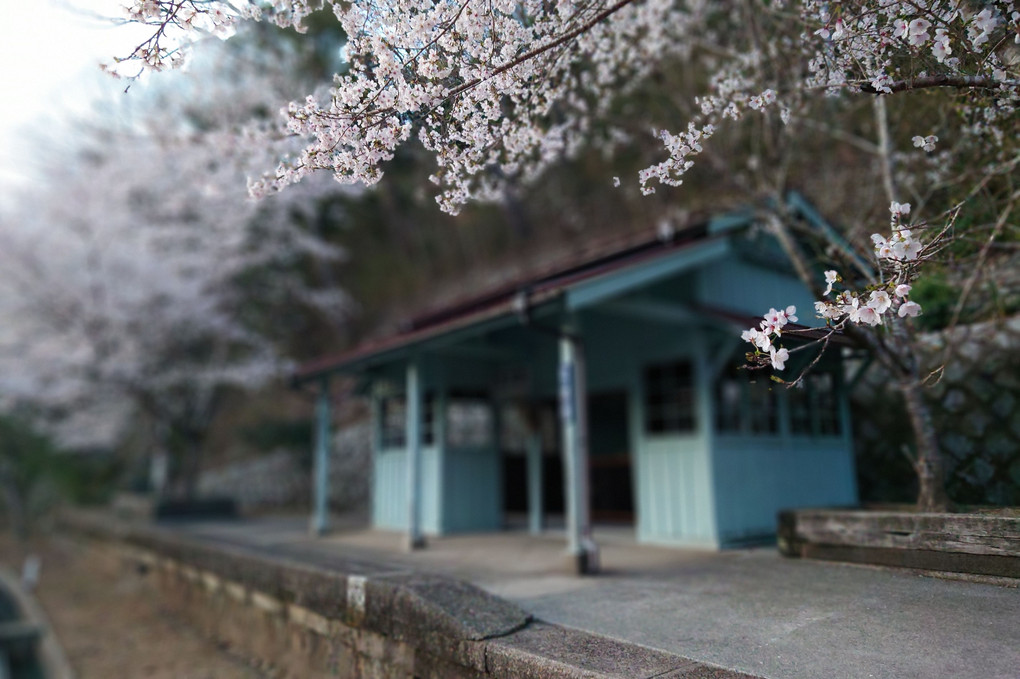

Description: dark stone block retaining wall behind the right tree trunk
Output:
[852,316,1020,506]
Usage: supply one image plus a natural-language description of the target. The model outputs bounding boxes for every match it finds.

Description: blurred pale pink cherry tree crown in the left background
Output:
[0,26,350,494]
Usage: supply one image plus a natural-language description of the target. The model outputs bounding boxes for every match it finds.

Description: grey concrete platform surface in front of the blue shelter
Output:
[172,517,1020,679]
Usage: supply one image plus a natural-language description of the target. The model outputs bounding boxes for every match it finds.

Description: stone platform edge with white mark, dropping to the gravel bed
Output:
[55,514,753,679]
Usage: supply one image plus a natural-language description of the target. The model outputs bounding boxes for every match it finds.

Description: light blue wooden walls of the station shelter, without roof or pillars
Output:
[374,247,856,547]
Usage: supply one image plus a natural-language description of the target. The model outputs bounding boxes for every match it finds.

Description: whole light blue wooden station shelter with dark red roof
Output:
[297,192,857,570]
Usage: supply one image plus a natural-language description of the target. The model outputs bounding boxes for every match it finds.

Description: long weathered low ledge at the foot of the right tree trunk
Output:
[778,510,1020,578]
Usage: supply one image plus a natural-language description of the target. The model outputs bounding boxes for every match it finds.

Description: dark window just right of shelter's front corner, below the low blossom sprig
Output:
[715,363,779,433]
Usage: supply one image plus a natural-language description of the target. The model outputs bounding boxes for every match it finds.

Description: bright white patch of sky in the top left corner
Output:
[0,0,150,190]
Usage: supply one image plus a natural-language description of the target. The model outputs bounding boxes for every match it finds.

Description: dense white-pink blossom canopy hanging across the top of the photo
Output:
[115,0,1020,212]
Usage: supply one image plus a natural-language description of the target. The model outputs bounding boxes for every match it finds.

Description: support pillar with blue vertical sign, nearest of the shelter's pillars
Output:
[560,331,599,575]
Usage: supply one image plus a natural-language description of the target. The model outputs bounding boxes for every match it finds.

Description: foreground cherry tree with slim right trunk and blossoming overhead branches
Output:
[115,0,1020,509]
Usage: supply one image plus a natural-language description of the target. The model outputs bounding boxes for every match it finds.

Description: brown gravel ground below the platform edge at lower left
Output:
[0,535,271,679]
